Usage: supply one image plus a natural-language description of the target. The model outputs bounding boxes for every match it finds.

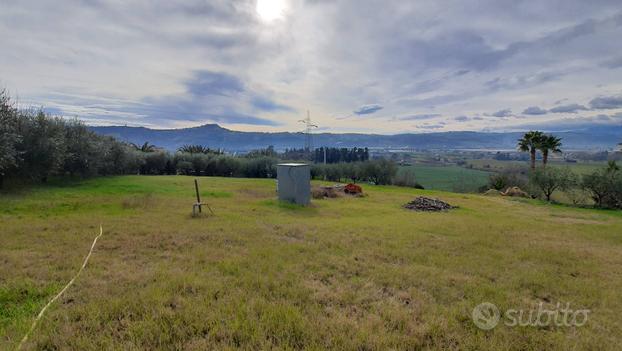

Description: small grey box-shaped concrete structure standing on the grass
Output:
[276,163,311,205]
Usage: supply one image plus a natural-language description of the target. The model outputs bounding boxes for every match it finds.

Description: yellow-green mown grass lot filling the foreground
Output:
[0,176,622,350]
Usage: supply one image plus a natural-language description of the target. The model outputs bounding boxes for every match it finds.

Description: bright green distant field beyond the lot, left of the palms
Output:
[399,164,490,192]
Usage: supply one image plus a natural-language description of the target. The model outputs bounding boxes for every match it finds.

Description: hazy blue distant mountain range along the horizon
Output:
[90,124,622,152]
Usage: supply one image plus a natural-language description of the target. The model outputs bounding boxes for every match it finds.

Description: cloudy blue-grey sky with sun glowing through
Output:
[0,0,622,134]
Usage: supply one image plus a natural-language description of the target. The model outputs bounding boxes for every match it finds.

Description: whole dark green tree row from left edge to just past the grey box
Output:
[0,91,404,187]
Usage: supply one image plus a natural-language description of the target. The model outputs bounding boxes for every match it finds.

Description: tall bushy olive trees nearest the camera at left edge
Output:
[0,91,140,186]
